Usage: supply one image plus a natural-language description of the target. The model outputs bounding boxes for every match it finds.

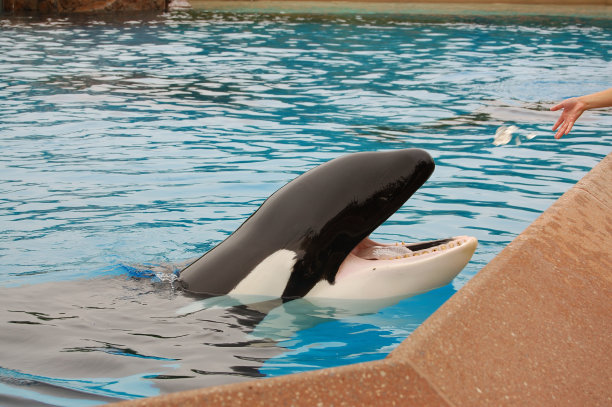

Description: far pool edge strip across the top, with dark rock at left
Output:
[0,0,612,18]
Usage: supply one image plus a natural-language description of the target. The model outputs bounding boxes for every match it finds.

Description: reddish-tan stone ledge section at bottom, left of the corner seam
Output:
[111,361,448,407]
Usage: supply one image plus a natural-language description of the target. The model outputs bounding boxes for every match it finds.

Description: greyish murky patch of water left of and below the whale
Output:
[0,276,282,405]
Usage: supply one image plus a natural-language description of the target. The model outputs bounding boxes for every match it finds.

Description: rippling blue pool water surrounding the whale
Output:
[0,12,612,406]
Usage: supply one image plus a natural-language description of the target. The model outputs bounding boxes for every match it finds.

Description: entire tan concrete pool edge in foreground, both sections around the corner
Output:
[111,153,612,407]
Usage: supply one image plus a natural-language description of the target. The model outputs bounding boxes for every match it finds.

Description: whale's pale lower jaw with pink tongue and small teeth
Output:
[306,236,478,299]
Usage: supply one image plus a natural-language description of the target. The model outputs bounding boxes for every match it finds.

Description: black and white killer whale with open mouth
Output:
[176,149,477,300]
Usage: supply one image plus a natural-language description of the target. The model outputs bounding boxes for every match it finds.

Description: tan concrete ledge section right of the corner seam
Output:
[390,154,612,406]
